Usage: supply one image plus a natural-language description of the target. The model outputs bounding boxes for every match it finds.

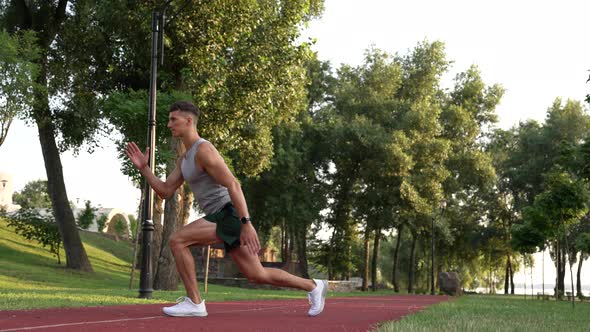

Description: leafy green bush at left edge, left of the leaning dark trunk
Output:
[3,209,62,264]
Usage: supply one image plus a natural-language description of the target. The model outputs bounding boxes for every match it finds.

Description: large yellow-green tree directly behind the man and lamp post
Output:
[100,1,323,287]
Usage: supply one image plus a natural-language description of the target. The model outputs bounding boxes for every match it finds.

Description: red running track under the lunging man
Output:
[0,295,449,332]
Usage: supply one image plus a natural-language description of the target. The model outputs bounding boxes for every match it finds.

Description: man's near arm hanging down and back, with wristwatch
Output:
[195,143,260,255]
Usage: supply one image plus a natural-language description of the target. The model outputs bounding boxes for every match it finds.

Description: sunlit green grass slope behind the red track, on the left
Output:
[0,219,390,310]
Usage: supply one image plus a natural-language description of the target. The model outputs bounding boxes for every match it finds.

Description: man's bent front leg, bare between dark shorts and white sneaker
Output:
[170,219,220,303]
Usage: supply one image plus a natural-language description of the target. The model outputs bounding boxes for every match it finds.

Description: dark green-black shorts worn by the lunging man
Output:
[203,202,242,252]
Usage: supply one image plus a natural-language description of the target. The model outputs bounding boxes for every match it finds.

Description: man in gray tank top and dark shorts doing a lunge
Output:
[126,101,328,317]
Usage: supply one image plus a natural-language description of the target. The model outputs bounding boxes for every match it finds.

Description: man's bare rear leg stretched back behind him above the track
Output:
[230,247,316,292]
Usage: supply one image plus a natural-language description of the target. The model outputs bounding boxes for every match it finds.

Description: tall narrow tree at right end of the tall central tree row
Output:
[438,65,504,294]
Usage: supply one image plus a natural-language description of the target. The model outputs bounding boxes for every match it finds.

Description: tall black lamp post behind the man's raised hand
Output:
[139,0,190,299]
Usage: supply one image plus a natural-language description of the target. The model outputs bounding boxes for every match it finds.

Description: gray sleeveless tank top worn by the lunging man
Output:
[180,138,231,214]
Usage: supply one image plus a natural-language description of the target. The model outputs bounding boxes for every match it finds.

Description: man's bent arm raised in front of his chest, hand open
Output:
[126,142,184,199]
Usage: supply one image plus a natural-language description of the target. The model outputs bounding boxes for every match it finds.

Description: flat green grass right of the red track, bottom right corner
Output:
[379,295,590,332]
